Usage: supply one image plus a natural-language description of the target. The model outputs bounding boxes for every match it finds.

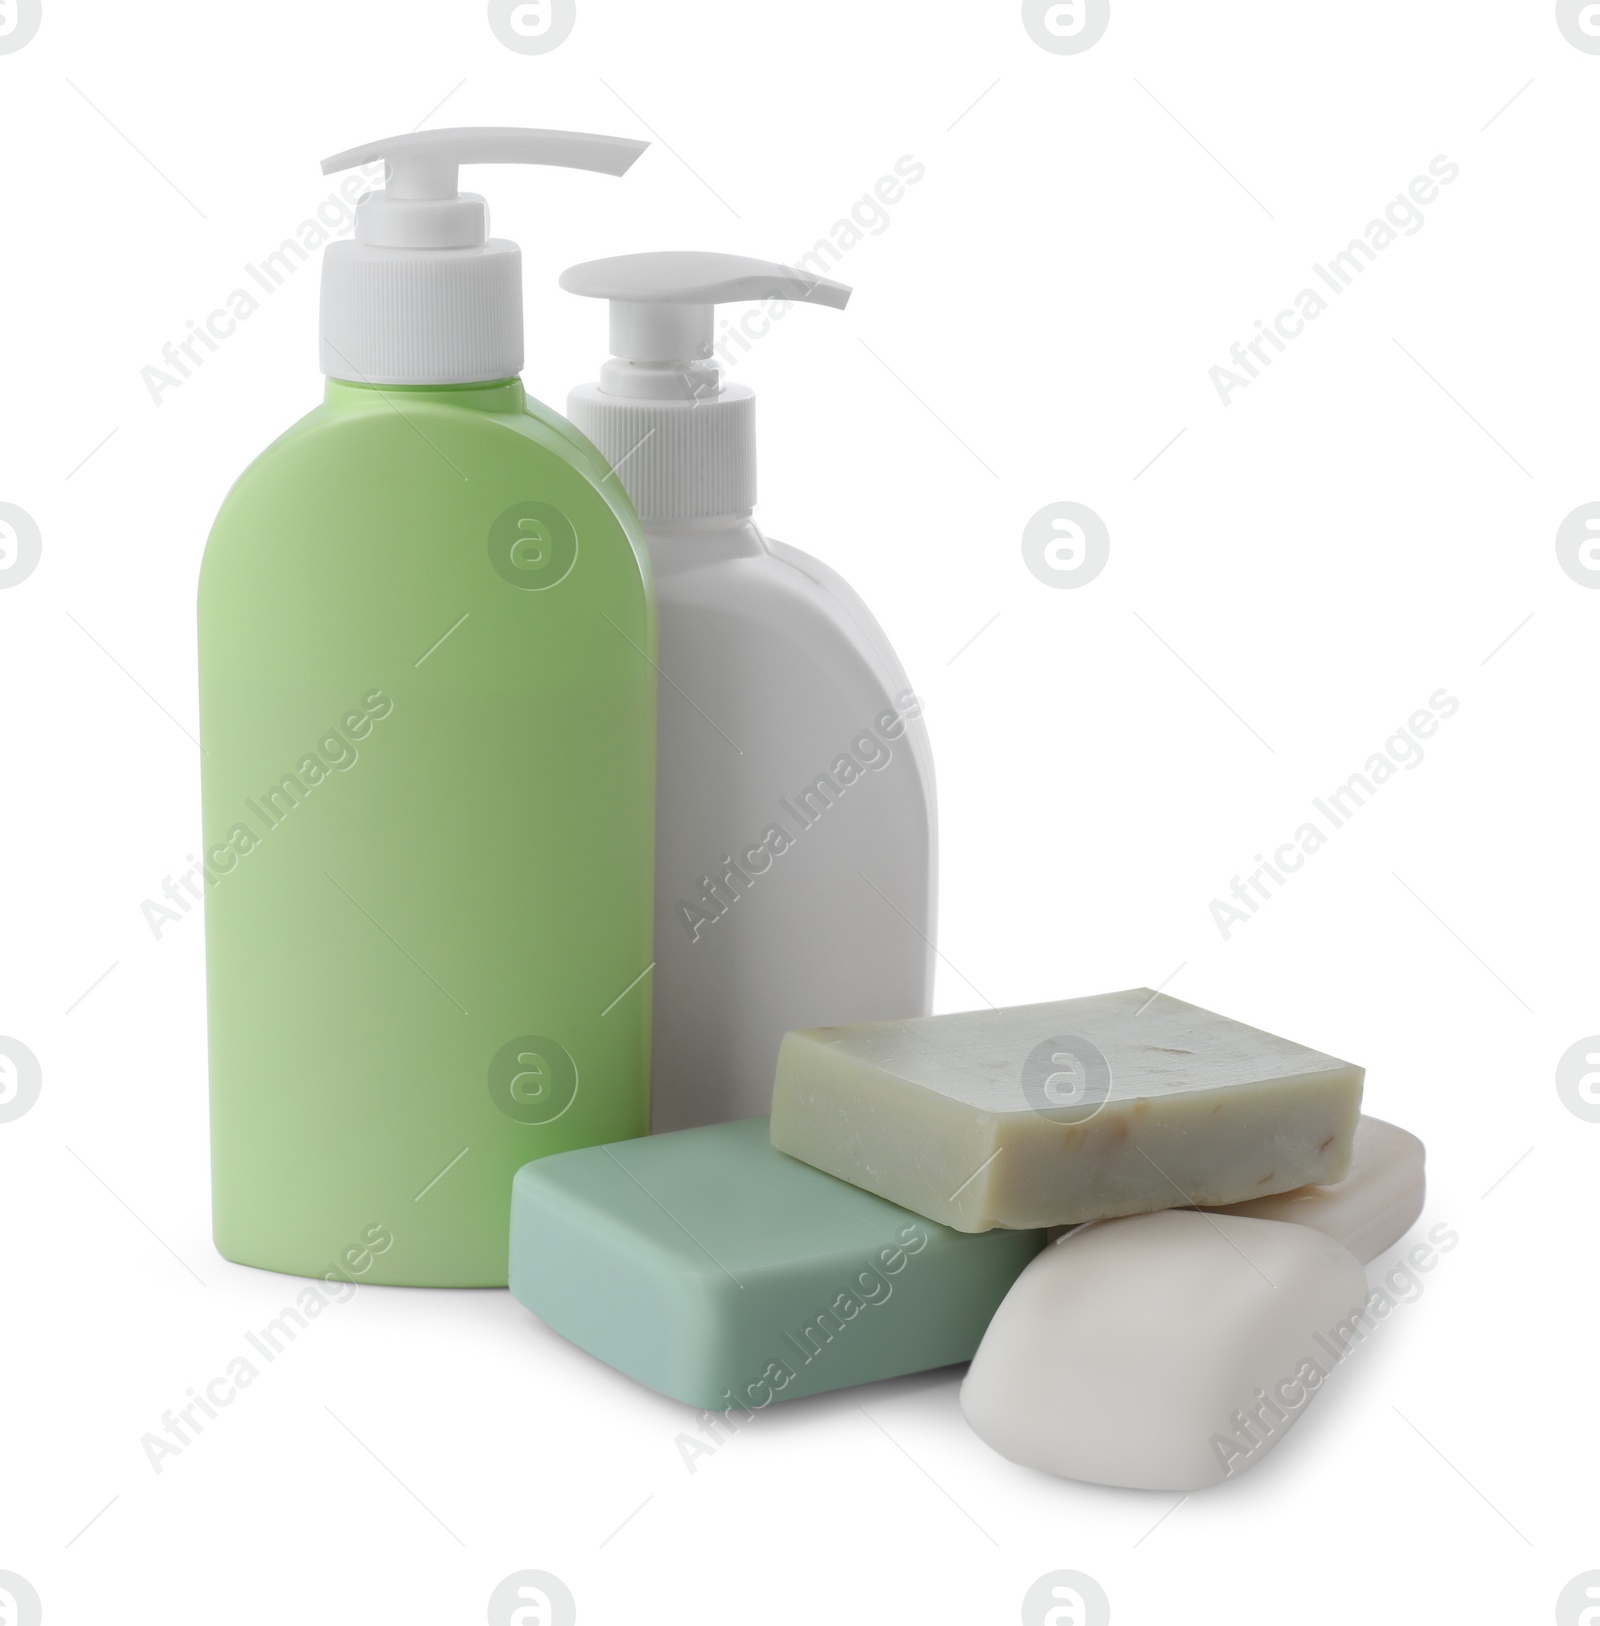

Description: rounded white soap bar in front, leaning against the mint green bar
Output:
[961,1210,1367,1491]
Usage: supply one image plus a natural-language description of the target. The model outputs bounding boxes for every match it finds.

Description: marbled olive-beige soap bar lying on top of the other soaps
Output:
[772,989,1364,1231]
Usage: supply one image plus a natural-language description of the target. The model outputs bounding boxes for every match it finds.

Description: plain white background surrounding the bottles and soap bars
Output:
[0,0,1600,1626]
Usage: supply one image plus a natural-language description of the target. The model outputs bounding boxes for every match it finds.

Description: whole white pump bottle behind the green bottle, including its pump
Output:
[561,254,935,1132]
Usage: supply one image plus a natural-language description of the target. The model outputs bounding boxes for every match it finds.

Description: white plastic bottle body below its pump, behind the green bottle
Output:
[647,520,937,1133]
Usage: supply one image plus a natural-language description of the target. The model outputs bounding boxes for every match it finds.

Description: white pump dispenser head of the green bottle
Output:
[322,128,649,384]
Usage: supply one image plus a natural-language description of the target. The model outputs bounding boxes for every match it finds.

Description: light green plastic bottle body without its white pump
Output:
[200,380,655,1286]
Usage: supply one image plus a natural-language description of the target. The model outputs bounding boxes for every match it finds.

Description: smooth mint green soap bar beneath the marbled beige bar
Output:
[511,1117,1044,1410]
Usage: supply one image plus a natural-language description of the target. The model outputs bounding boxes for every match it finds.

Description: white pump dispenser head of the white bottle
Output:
[561,254,850,522]
